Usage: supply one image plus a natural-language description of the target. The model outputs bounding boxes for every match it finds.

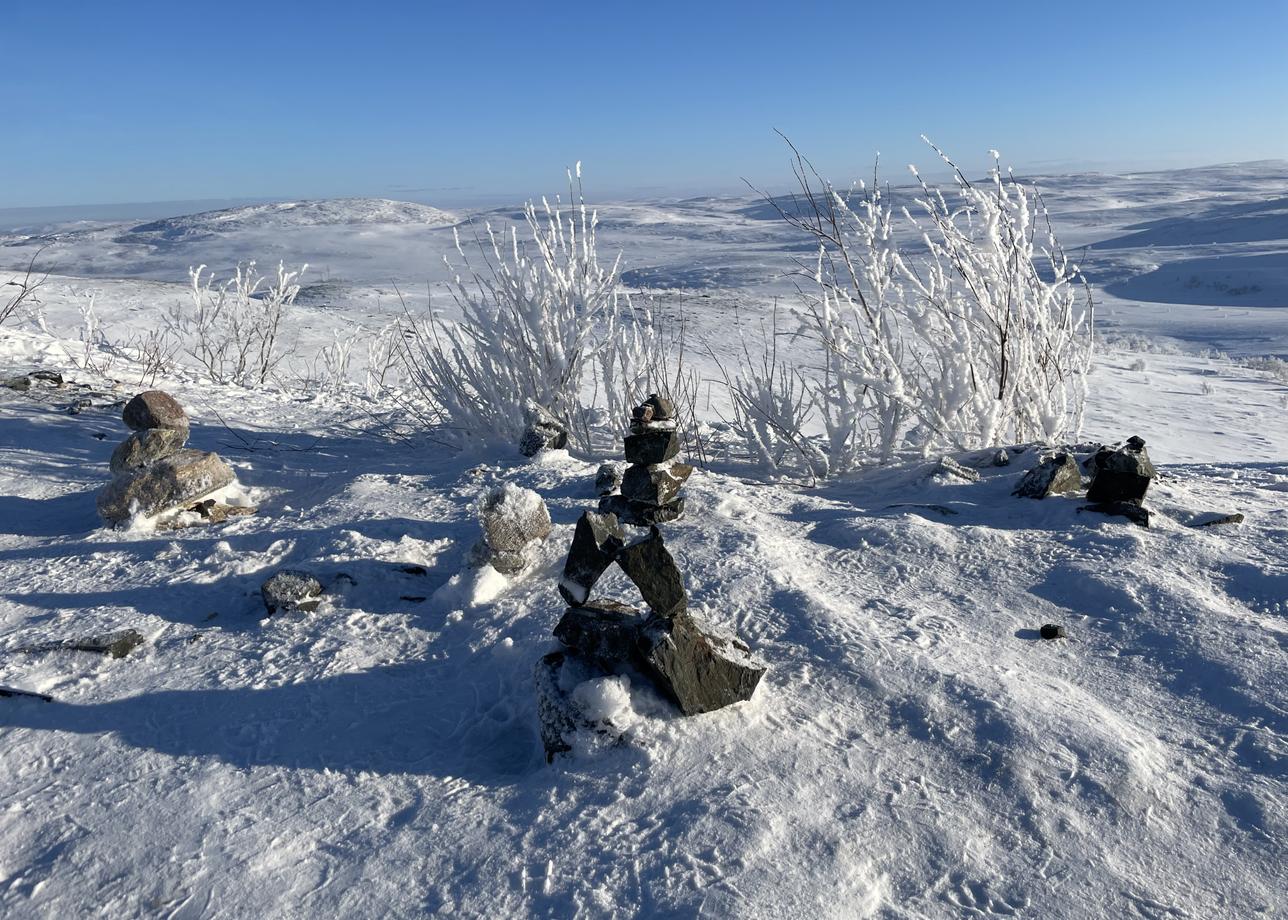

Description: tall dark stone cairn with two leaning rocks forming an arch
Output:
[536,396,765,762]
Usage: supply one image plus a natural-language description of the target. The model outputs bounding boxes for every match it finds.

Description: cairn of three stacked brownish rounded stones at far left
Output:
[98,389,245,526]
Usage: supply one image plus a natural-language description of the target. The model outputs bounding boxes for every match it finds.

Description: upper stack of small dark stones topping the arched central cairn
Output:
[595,393,693,526]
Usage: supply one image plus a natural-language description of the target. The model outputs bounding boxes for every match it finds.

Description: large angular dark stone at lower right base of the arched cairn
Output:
[640,612,765,715]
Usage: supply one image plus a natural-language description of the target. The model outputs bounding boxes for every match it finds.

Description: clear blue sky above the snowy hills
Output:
[0,0,1288,207]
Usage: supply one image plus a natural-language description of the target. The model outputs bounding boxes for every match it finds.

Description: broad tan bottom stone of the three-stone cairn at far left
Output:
[98,448,236,524]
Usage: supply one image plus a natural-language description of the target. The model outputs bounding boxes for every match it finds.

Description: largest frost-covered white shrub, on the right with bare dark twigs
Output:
[755,142,1092,473]
